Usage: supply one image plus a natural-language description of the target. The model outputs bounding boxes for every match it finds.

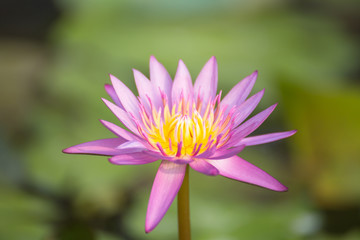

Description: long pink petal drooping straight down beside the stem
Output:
[145,161,186,233]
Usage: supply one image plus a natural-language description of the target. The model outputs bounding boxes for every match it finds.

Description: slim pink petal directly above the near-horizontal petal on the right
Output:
[229,104,277,146]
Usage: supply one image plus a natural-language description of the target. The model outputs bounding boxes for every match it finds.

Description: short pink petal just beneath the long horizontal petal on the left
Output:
[109,152,158,165]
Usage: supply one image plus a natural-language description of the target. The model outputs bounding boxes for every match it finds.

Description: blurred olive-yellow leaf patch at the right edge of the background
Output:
[282,81,360,208]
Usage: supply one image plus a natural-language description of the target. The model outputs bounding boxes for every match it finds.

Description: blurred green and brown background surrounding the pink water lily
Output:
[0,0,360,240]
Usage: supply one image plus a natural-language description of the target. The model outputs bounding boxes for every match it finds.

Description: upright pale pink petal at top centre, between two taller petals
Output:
[171,60,194,103]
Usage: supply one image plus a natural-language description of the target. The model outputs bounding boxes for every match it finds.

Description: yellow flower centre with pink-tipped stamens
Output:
[138,94,232,158]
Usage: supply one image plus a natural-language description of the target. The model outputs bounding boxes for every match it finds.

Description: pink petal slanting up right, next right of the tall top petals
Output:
[221,71,258,109]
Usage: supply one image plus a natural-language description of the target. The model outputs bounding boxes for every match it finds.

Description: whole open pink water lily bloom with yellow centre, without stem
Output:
[64,56,296,232]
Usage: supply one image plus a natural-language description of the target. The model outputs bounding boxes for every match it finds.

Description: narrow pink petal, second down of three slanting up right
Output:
[233,89,265,127]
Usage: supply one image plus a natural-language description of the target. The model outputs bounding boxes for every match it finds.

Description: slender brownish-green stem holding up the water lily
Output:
[178,165,191,240]
